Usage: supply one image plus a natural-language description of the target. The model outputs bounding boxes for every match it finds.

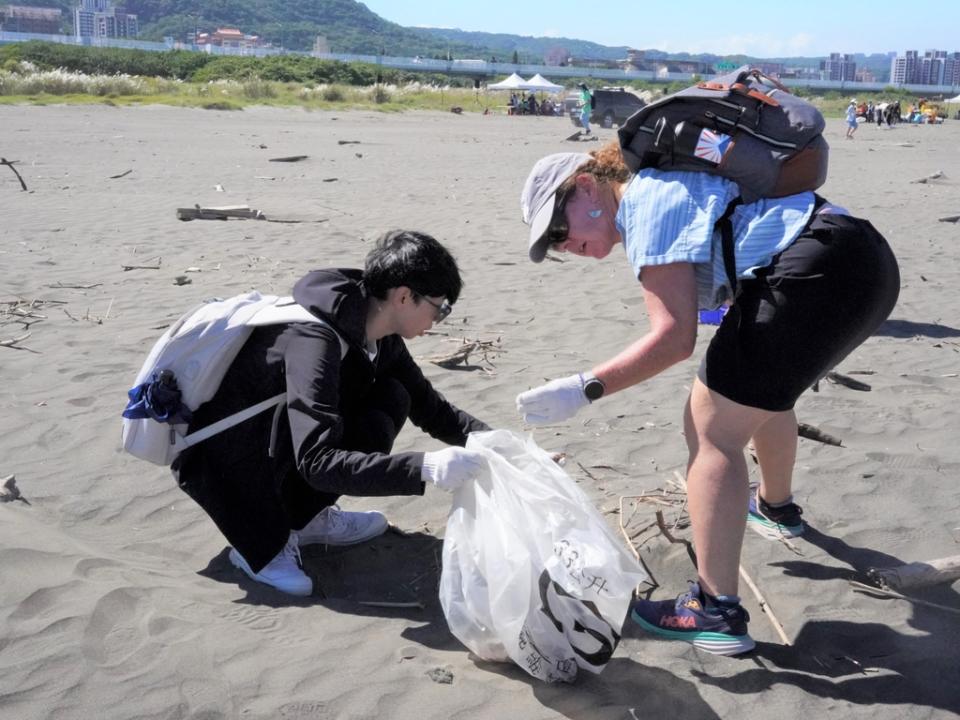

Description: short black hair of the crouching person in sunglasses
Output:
[363,230,463,305]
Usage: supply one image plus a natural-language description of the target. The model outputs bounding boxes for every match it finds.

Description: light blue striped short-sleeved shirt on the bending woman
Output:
[617,169,814,308]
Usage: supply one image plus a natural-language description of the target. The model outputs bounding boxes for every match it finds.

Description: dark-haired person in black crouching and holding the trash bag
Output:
[175,231,489,595]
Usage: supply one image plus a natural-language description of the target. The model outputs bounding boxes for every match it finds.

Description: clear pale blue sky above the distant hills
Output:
[363,0,960,57]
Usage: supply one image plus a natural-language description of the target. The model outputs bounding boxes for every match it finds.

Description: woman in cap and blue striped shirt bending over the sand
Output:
[517,141,900,655]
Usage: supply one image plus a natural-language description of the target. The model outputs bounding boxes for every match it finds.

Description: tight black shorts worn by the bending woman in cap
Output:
[699,213,900,411]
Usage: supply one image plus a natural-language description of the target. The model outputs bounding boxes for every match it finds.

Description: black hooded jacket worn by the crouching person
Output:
[181,270,489,496]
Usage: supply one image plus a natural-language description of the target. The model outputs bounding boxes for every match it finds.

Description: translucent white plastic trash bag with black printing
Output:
[440,430,647,682]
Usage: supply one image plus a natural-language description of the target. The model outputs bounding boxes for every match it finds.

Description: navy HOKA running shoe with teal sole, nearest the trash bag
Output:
[630,583,756,655]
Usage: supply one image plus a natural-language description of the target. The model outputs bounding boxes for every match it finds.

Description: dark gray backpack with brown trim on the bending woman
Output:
[619,66,829,203]
